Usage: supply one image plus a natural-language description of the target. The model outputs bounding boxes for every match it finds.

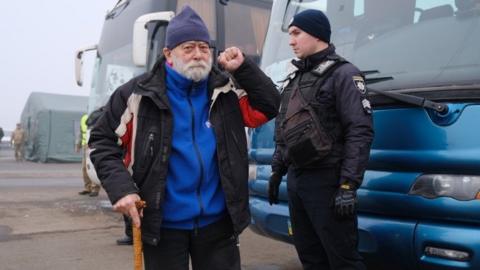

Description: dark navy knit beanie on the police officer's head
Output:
[288,9,331,43]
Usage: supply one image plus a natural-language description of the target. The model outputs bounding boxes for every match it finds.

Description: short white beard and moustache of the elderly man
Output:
[172,54,212,82]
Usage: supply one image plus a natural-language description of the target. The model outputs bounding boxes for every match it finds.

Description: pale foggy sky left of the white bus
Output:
[0,0,117,130]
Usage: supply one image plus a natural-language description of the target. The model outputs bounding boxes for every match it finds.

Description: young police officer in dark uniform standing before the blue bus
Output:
[269,10,373,270]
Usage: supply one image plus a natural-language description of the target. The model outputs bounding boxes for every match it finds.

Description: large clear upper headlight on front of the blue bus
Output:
[408,174,480,201]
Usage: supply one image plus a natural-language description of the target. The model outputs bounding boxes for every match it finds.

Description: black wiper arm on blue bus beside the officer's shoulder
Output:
[362,70,448,114]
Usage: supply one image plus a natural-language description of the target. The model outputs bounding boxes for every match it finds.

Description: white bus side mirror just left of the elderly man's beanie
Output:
[132,11,175,67]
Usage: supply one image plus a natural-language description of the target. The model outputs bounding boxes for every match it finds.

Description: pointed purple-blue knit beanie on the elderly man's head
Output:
[165,5,210,50]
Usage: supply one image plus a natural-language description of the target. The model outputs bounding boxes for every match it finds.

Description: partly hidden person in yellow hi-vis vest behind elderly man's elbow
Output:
[76,114,100,197]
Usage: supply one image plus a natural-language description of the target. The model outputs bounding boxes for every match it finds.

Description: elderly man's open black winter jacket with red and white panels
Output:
[89,59,280,245]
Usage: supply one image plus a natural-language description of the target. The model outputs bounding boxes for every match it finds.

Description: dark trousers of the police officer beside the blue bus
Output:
[288,168,366,270]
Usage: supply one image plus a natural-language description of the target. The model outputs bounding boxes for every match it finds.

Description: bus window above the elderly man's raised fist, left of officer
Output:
[225,2,270,62]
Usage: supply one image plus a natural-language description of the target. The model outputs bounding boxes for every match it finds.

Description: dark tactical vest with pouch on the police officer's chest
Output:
[275,55,347,168]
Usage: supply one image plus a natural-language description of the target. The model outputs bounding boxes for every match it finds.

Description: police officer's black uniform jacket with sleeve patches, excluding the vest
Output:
[272,44,374,187]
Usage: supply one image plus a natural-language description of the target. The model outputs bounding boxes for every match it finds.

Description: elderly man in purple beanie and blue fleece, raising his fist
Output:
[89,6,280,270]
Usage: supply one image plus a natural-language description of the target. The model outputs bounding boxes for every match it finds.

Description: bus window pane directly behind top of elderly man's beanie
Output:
[175,0,217,40]
